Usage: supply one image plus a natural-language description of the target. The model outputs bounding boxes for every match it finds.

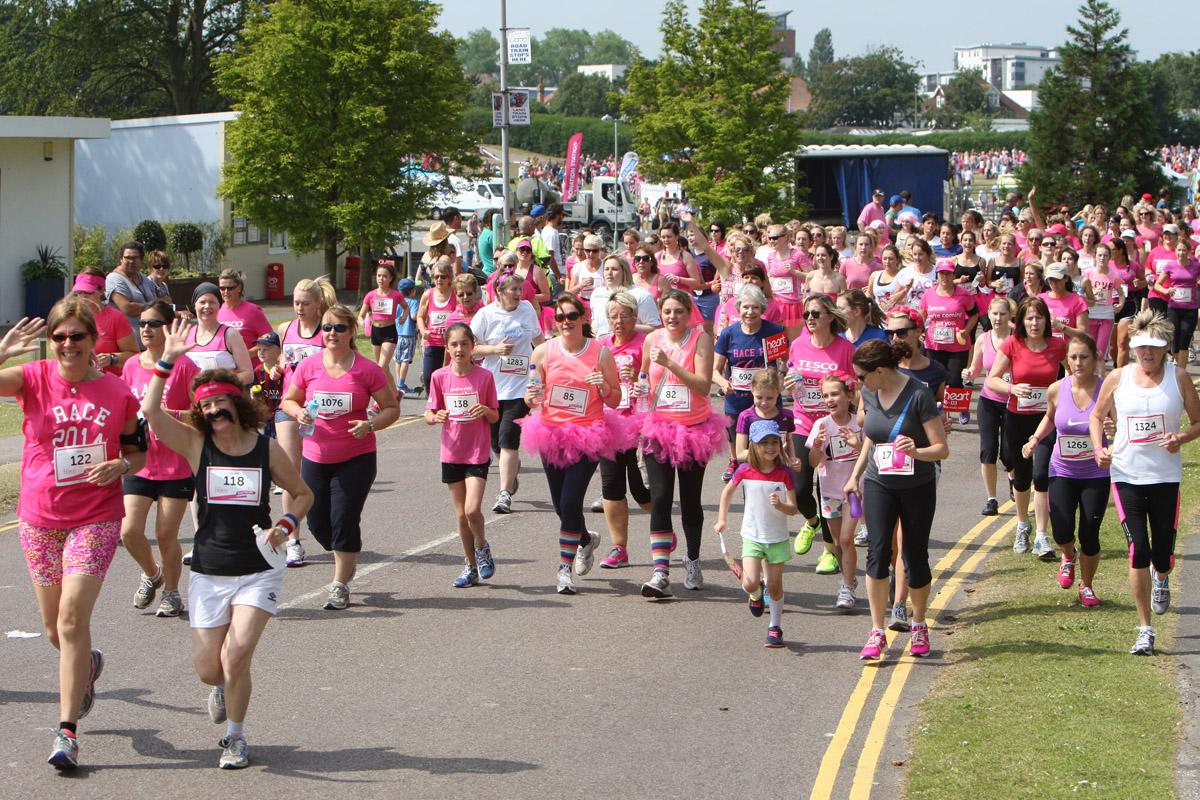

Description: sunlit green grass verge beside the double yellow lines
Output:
[906,443,1200,800]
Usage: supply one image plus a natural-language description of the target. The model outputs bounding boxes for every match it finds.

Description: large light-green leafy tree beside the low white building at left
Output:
[217,0,478,275]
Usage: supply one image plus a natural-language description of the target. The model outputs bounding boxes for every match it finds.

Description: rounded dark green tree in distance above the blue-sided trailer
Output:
[809,47,920,128]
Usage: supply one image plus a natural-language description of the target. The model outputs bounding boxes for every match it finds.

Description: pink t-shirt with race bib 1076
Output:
[292,353,388,464]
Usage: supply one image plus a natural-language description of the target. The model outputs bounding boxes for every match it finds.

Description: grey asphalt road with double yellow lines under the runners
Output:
[0,401,1012,800]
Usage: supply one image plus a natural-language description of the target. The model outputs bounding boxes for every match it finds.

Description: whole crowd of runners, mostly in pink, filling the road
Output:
[9,185,1200,769]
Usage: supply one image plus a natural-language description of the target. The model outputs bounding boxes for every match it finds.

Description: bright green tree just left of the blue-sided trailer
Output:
[622,0,800,217]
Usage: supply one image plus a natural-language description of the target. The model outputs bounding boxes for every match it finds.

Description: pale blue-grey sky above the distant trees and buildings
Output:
[440,0,1200,72]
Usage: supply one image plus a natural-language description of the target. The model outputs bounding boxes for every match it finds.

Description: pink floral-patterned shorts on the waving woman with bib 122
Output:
[20,519,121,587]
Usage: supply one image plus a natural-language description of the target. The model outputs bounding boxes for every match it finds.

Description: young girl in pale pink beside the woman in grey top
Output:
[808,373,863,609]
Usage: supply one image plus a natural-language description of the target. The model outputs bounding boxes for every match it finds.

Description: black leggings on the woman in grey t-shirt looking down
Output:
[863,481,937,589]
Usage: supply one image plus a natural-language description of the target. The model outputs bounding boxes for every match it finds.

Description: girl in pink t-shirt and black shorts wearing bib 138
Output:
[425,323,500,589]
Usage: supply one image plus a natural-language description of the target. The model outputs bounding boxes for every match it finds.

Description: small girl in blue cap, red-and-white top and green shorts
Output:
[713,420,797,648]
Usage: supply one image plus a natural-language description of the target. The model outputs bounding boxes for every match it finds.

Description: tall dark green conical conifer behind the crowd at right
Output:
[1020,0,1160,207]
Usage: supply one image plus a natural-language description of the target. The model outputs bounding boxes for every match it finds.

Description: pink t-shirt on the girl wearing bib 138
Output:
[425,365,499,464]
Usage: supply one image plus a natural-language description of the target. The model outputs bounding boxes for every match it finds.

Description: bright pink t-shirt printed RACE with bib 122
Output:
[17,359,138,528]
